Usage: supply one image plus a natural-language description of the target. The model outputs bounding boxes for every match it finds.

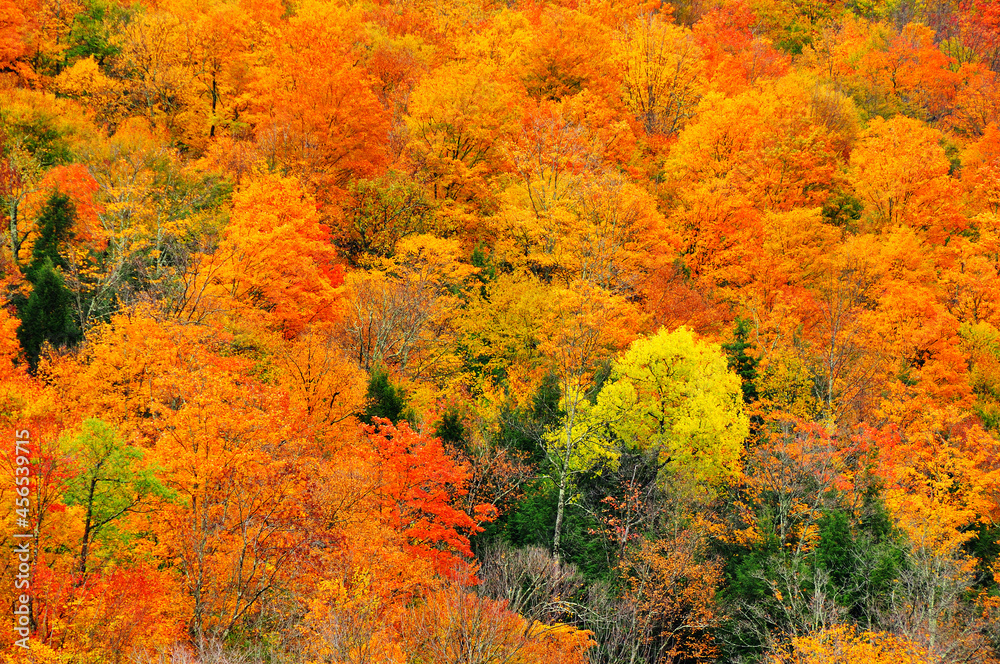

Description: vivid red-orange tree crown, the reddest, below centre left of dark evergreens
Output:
[361,418,478,578]
